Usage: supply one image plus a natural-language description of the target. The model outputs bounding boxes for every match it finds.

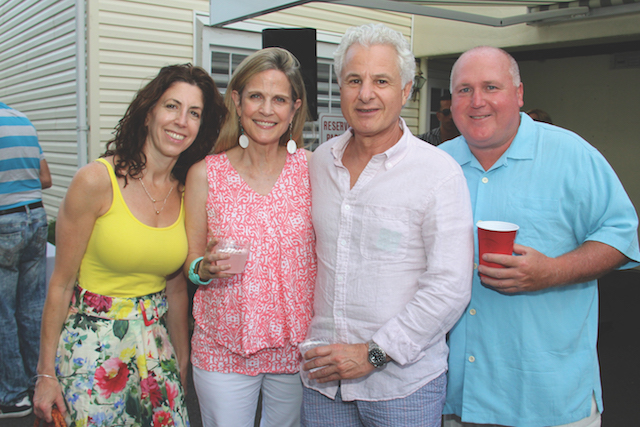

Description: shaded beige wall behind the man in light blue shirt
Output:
[520,55,640,234]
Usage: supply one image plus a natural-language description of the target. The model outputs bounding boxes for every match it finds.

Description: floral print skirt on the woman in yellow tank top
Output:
[56,286,189,427]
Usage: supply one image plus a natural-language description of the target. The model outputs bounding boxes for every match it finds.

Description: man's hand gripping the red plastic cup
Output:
[478,244,558,293]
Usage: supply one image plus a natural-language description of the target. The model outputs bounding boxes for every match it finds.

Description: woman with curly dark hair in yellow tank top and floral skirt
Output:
[34,64,226,426]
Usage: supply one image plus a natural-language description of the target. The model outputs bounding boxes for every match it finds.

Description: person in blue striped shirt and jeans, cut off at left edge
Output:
[0,102,51,419]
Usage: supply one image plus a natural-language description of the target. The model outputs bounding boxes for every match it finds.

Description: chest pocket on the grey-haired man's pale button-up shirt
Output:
[360,205,410,261]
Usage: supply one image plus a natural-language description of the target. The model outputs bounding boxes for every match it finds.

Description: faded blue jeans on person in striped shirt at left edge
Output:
[0,208,47,405]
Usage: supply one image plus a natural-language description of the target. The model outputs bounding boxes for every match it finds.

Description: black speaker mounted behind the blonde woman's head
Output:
[262,28,318,121]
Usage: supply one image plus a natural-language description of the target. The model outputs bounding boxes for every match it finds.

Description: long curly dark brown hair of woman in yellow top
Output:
[102,64,227,185]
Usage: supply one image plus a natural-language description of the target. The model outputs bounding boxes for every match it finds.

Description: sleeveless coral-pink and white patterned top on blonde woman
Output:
[191,150,316,375]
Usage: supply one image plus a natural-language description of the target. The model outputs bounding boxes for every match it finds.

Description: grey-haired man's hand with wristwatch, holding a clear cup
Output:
[303,343,375,383]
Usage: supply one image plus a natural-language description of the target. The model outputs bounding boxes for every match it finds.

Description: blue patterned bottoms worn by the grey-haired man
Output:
[301,372,447,427]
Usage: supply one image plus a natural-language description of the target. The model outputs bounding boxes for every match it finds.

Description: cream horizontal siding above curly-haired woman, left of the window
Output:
[88,0,209,159]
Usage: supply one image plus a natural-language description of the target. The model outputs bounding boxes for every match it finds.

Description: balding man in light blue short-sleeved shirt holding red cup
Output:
[440,47,640,427]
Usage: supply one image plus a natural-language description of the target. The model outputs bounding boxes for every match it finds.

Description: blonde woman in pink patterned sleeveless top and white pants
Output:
[185,48,316,427]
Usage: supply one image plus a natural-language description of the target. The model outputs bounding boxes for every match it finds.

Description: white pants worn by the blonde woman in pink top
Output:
[193,366,302,427]
